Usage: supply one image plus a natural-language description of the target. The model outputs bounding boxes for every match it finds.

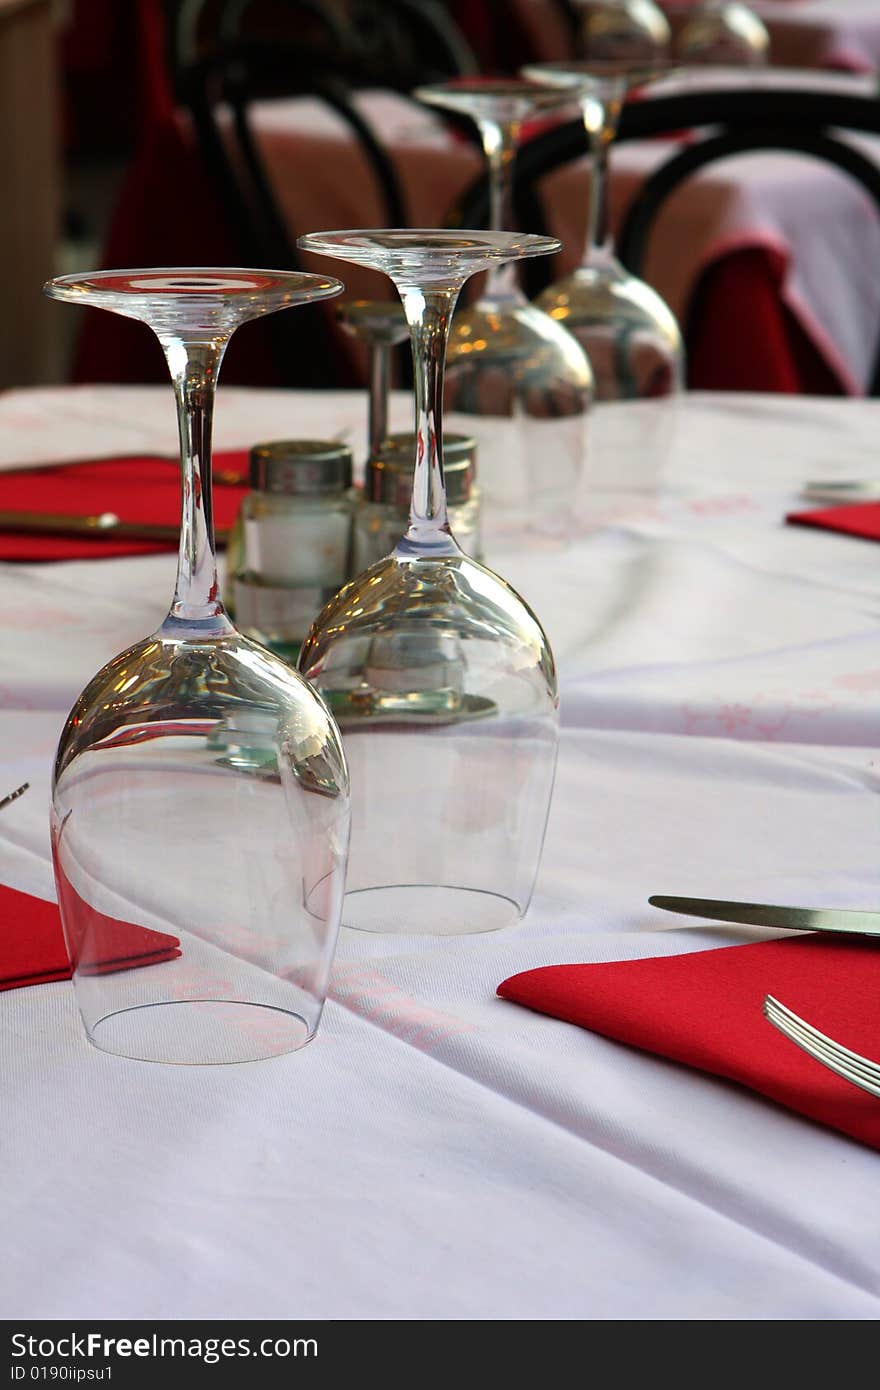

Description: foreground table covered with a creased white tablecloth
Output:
[0,386,880,1321]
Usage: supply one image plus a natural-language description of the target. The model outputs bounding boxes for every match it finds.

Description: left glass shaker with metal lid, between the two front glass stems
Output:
[225,439,353,662]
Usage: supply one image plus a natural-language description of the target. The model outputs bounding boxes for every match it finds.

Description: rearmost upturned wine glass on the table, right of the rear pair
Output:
[524,61,684,402]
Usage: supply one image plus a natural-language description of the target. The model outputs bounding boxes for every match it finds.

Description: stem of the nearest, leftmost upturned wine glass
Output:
[160,336,231,632]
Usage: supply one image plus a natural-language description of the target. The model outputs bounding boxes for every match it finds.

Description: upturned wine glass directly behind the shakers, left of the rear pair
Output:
[413,79,594,525]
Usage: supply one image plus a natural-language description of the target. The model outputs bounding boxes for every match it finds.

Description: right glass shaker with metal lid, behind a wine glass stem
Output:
[352,432,482,575]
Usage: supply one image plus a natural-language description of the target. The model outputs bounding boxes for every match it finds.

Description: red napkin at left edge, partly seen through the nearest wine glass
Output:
[0,884,181,990]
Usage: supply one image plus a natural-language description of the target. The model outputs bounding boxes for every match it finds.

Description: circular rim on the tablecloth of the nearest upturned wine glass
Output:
[88,999,317,1066]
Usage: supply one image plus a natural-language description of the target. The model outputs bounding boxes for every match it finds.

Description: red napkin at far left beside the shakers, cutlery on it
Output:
[0,450,247,560]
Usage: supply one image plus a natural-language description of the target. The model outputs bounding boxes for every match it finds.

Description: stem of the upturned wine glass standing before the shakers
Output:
[398,285,460,550]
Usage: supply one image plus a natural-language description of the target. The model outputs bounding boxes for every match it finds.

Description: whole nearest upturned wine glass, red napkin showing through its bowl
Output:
[44,268,350,1063]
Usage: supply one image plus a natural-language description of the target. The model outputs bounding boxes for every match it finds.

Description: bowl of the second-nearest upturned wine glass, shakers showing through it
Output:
[294,550,556,935]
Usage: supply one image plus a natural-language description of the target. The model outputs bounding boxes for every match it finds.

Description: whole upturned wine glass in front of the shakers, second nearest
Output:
[299,229,559,935]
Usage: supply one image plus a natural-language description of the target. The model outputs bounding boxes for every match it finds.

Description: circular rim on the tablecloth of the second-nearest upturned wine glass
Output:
[342,883,523,937]
